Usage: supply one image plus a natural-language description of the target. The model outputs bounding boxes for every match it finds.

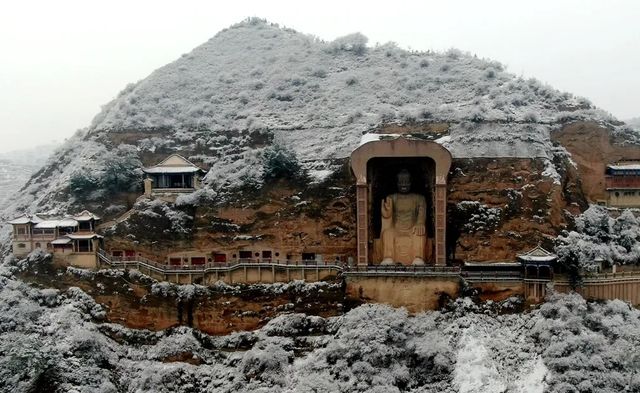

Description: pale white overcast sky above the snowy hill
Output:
[0,0,640,152]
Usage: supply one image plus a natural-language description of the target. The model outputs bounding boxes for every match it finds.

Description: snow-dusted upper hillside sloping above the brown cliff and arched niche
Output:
[4,19,635,224]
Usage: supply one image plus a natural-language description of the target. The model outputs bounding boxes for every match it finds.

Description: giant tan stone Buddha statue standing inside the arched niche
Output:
[380,169,427,266]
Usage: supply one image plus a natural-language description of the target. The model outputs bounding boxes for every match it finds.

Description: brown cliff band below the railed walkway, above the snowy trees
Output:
[20,267,355,335]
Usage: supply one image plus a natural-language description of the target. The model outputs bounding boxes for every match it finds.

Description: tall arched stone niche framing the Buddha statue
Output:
[351,134,451,265]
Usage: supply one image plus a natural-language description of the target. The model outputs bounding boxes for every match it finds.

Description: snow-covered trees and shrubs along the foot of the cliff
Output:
[0,256,640,393]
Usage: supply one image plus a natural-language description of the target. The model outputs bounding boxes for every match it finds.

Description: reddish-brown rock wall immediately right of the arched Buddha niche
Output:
[447,158,584,262]
